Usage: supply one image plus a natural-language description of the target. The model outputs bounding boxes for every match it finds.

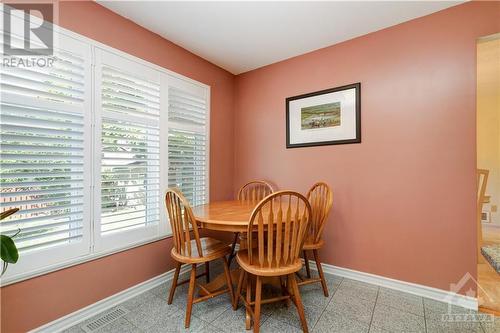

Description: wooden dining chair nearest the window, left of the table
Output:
[165,189,234,328]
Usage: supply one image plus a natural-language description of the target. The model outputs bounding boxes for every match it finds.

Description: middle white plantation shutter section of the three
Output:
[95,50,163,249]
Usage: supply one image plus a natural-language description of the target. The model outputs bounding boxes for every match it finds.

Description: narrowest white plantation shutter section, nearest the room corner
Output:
[168,77,209,206]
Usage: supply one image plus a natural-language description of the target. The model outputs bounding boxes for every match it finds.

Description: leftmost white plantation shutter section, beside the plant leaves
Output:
[0,34,91,276]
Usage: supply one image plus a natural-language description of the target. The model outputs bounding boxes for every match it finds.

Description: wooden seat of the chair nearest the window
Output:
[171,237,231,264]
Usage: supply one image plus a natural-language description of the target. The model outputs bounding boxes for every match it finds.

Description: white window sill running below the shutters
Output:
[0,234,172,287]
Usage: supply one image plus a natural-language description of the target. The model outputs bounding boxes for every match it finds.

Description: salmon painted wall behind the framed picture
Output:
[234,2,500,292]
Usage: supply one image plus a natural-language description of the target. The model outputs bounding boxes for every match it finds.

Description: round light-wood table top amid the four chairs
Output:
[192,200,257,232]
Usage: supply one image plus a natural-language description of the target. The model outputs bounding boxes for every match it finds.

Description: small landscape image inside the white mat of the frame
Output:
[300,102,340,130]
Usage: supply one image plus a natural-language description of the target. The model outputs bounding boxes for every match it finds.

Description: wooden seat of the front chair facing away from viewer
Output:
[236,249,302,276]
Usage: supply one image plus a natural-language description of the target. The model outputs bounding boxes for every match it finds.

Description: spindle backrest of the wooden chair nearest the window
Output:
[165,188,203,257]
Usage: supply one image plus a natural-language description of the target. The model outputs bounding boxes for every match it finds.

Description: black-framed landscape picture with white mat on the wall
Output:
[286,83,361,148]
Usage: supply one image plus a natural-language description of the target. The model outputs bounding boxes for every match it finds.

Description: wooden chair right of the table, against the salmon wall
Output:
[299,182,333,297]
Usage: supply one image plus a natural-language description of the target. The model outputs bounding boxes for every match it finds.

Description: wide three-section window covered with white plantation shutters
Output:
[0,18,210,284]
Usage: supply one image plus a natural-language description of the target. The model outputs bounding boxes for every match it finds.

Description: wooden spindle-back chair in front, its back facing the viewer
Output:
[233,191,311,332]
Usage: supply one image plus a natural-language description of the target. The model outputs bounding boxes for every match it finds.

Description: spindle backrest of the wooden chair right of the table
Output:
[306,182,333,243]
